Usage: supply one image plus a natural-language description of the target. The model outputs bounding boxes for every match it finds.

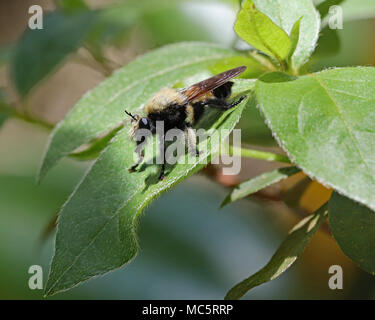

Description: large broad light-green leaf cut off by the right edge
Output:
[256,67,375,209]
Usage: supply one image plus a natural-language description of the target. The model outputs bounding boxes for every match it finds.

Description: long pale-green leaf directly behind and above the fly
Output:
[39,43,244,178]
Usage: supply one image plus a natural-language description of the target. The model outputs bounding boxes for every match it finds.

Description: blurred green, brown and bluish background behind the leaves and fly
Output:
[0,0,375,299]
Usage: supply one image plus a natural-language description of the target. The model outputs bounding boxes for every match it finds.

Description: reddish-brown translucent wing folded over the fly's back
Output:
[180,66,246,103]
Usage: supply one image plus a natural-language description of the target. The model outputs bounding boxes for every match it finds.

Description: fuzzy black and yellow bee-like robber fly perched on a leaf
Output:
[125,66,246,180]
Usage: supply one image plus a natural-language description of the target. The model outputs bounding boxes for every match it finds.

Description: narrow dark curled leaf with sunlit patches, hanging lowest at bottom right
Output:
[225,205,328,300]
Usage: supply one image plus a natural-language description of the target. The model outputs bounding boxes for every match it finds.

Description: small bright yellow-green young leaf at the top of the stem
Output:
[234,0,290,61]
